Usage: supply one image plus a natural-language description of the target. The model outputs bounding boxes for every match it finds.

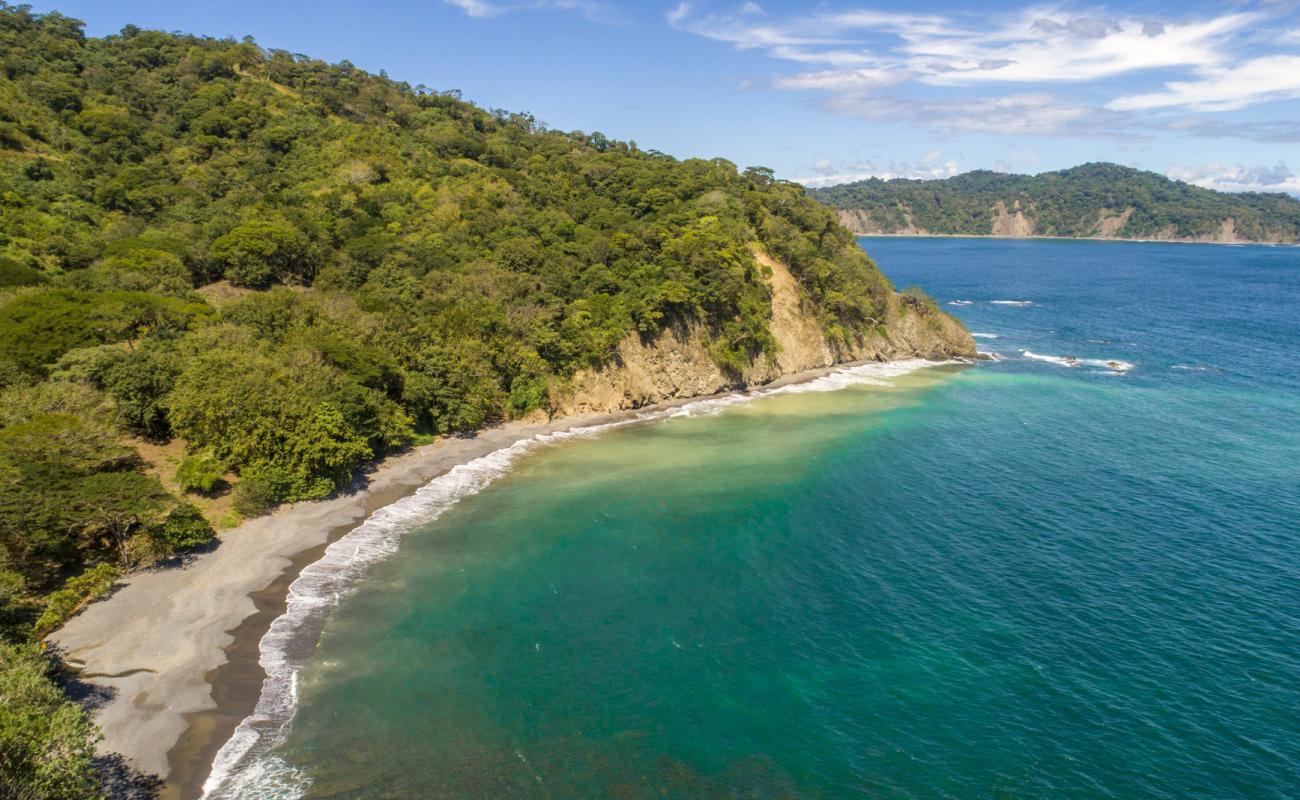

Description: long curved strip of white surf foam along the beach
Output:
[203,359,962,800]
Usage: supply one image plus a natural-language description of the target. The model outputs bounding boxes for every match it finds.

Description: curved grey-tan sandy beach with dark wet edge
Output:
[49,362,915,800]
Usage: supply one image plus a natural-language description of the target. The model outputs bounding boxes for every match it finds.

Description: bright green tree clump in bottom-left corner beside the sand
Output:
[0,641,104,800]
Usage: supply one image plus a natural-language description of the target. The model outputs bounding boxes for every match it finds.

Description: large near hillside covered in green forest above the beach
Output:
[0,5,967,686]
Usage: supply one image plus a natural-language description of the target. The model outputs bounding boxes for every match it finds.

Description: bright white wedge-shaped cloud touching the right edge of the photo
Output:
[1106,55,1300,111]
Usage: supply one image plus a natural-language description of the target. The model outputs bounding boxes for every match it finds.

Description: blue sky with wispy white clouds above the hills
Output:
[33,0,1300,195]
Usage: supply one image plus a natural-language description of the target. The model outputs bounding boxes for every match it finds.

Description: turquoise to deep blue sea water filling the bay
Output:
[213,239,1300,799]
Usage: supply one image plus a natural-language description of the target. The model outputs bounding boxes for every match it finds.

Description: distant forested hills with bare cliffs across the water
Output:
[809,164,1300,243]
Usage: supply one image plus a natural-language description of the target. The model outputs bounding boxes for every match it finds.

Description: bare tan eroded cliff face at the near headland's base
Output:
[551,251,975,415]
